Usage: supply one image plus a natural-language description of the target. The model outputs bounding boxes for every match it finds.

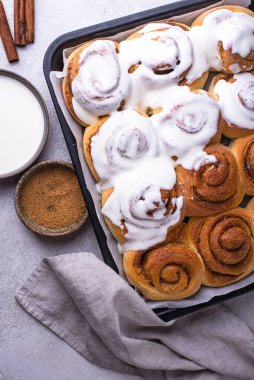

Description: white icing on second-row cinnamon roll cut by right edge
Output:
[214,73,254,129]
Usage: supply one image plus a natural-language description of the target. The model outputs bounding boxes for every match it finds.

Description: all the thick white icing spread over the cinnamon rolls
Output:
[75,9,254,251]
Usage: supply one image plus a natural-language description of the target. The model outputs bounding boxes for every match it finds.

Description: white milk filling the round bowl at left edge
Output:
[0,75,44,175]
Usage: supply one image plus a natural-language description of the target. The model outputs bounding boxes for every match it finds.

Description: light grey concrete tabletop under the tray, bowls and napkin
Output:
[0,0,175,380]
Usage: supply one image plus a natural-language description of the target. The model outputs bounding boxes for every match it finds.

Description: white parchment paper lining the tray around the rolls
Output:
[50,0,254,308]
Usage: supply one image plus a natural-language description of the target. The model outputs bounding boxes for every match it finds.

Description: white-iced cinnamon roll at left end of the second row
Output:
[83,109,159,185]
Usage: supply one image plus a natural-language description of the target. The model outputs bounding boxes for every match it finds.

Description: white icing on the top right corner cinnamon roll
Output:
[186,9,254,83]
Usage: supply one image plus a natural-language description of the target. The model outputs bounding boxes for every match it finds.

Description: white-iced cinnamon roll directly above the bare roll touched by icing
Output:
[151,90,221,170]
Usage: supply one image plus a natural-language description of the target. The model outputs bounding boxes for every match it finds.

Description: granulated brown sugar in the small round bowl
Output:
[21,167,86,229]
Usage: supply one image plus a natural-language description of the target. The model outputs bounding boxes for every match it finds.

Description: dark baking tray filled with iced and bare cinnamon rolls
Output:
[44,1,254,319]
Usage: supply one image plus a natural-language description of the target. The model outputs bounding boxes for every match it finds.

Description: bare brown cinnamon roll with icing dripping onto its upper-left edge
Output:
[177,144,245,216]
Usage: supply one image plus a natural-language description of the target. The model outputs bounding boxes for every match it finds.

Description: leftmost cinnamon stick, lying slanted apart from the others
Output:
[0,0,19,62]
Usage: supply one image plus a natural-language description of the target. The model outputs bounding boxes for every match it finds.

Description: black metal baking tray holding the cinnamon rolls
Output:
[43,0,254,321]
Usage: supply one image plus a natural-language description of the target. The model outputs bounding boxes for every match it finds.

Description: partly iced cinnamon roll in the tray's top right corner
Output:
[189,6,254,78]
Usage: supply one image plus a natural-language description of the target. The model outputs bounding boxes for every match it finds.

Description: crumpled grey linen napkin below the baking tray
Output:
[16,252,254,380]
